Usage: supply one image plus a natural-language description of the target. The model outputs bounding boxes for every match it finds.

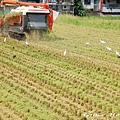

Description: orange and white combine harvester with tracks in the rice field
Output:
[0,0,59,40]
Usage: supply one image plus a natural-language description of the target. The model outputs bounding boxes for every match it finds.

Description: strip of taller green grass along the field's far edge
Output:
[57,14,120,30]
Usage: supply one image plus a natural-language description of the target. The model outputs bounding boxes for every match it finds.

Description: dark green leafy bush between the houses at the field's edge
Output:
[74,0,86,16]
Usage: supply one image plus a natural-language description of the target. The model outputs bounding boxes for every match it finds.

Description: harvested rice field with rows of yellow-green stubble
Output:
[0,15,120,120]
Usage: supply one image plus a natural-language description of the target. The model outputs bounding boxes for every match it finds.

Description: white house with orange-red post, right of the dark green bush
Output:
[81,0,120,15]
